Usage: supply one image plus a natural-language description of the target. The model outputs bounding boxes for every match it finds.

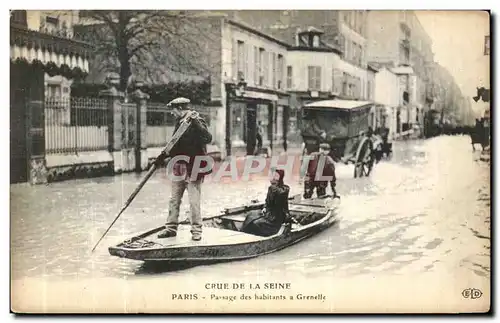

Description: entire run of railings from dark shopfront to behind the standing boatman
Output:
[45,97,219,154]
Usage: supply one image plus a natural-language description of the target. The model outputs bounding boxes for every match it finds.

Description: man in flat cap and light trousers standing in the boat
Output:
[157,98,212,241]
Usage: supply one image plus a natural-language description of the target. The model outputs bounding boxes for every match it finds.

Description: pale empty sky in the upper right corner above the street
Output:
[416,11,490,115]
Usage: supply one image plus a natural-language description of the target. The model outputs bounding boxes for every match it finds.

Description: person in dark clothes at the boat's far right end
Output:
[304,143,338,199]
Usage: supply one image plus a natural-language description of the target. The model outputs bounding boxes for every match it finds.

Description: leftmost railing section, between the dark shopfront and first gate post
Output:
[45,98,109,154]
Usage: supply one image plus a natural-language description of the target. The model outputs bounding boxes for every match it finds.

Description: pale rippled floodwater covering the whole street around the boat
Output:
[11,136,490,280]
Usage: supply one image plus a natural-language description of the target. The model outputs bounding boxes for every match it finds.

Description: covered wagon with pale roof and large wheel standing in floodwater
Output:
[302,100,390,177]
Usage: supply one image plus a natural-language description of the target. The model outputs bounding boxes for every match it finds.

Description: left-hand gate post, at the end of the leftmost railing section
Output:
[100,78,124,173]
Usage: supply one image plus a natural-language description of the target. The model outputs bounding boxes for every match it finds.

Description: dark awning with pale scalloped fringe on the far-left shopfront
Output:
[10,25,92,72]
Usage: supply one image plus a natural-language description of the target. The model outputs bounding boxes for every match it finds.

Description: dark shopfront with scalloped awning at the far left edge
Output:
[10,10,92,183]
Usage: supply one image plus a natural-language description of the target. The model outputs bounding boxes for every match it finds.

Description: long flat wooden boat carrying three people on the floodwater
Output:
[109,196,339,263]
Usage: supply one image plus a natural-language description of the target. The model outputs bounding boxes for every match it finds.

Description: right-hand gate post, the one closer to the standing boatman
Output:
[132,82,149,172]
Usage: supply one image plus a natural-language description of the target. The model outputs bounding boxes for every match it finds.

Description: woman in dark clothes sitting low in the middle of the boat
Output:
[240,169,290,237]
